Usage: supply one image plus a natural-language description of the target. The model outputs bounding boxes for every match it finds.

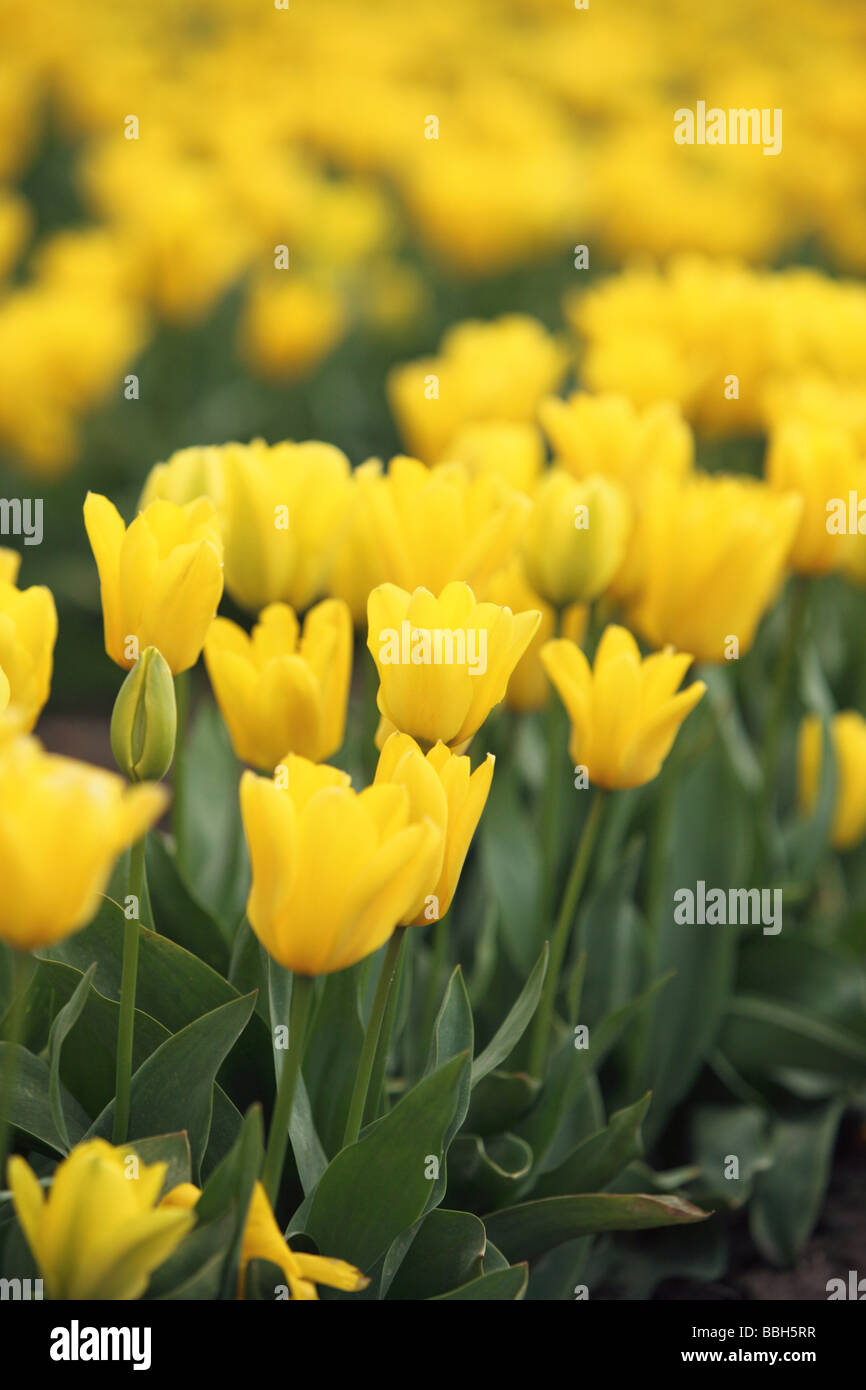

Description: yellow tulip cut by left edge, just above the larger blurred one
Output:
[0,550,57,742]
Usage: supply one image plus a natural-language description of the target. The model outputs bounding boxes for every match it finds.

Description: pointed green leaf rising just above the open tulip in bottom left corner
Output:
[90,994,256,1180]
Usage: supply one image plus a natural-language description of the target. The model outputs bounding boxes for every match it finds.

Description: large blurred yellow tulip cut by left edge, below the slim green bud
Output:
[0,738,167,951]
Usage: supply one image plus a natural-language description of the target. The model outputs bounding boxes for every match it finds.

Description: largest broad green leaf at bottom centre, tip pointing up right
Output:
[304,1052,470,1272]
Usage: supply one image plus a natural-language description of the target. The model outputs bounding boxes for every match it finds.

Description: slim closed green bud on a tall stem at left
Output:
[111,646,178,781]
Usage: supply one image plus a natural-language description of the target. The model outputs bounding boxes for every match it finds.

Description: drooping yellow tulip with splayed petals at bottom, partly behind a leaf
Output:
[160,1183,370,1302]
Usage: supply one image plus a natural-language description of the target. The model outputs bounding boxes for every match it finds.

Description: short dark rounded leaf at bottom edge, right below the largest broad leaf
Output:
[388,1207,487,1300]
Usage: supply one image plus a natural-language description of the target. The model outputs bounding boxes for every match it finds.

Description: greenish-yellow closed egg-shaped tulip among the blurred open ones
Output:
[523,468,631,607]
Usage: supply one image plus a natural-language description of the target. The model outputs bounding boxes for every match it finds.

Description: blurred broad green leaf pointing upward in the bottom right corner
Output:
[748,1099,845,1265]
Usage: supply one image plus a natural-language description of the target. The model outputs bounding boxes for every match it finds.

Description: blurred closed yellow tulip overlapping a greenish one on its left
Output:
[222,441,352,613]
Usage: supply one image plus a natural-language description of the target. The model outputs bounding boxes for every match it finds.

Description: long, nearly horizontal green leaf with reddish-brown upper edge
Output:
[484,1193,710,1261]
